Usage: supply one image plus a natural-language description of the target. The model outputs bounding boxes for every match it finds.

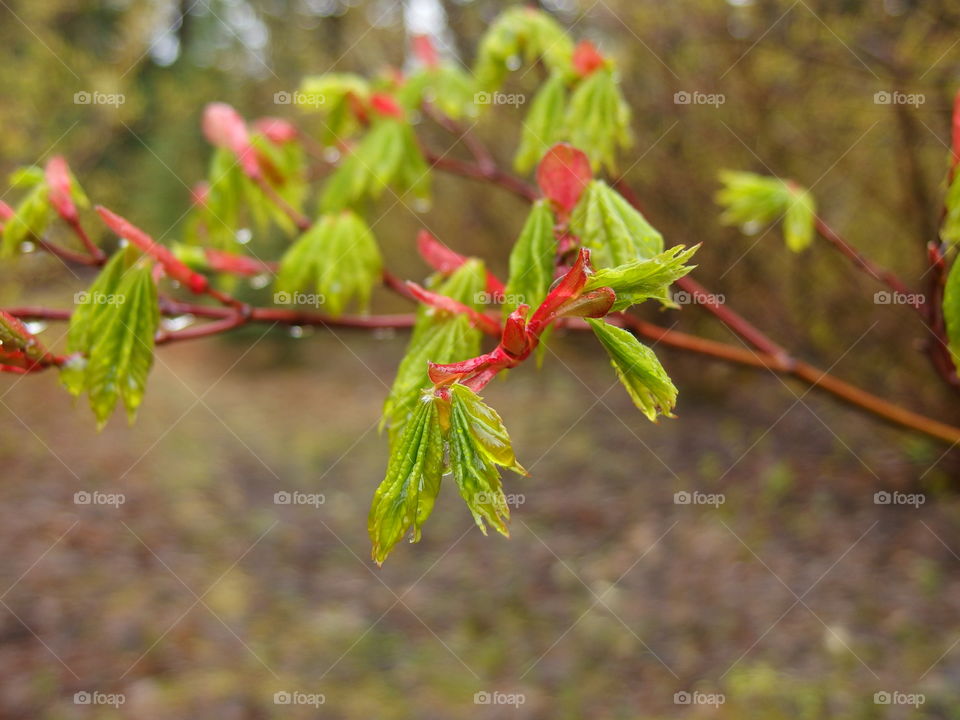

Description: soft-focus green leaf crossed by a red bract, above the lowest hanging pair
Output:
[381,260,486,445]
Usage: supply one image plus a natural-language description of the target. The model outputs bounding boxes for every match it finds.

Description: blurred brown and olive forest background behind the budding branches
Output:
[0,0,960,720]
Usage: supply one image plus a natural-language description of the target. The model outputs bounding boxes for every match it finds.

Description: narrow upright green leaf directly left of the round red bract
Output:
[503,200,557,316]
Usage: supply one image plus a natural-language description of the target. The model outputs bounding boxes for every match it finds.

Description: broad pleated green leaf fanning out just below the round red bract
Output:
[570,180,663,268]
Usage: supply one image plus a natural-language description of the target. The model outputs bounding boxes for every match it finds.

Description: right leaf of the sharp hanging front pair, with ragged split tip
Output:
[449,383,527,536]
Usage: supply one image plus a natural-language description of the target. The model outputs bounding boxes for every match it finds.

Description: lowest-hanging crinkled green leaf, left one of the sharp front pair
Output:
[367,392,443,565]
